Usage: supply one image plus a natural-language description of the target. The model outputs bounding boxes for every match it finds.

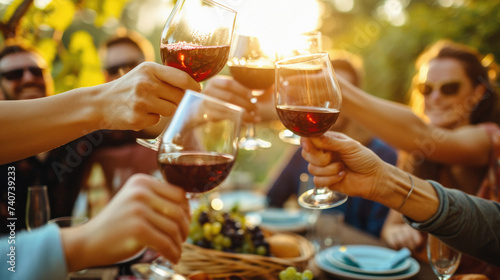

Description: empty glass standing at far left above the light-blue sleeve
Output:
[26,185,50,231]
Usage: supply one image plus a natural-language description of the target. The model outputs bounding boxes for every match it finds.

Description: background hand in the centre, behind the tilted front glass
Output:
[203,75,261,122]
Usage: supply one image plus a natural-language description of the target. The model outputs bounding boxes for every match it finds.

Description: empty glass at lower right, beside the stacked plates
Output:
[427,234,462,280]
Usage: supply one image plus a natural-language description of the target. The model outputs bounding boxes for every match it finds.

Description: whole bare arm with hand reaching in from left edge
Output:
[0,62,200,164]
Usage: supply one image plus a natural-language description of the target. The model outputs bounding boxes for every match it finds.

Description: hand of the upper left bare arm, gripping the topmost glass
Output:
[97,62,201,130]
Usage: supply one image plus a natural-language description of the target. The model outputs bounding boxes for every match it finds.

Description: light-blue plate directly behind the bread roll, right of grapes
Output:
[246,208,309,232]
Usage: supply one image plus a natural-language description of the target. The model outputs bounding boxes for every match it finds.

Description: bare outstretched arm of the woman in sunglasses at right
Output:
[338,77,491,165]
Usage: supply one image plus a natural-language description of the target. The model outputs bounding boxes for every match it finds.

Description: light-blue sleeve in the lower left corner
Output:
[0,224,67,280]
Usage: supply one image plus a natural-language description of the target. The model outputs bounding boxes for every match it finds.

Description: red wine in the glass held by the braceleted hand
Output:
[276,105,340,137]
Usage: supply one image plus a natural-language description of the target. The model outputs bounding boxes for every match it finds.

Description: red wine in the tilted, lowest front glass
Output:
[158,152,234,193]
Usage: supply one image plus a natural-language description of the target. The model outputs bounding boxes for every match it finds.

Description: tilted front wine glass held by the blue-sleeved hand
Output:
[151,90,244,275]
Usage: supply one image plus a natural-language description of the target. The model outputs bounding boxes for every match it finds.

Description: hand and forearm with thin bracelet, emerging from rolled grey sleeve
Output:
[301,131,439,221]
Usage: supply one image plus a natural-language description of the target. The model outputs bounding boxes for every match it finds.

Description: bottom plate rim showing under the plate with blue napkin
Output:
[314,249,420,280]
